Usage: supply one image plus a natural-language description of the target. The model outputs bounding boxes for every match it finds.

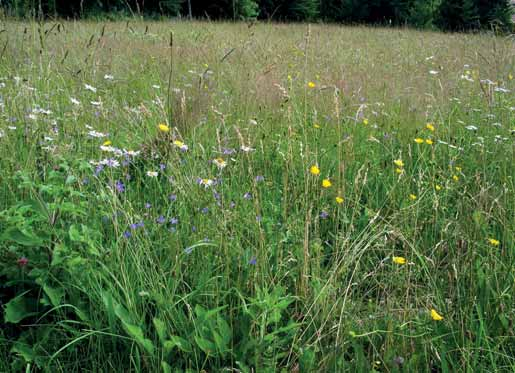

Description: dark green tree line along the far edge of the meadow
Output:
[0,0,514,30]
